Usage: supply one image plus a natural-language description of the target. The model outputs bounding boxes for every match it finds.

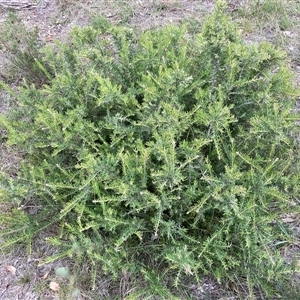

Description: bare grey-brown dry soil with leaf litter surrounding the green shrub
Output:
[0,0,300,300]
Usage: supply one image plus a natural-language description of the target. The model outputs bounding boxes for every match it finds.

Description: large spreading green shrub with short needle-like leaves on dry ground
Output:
[1,1,299,299]
